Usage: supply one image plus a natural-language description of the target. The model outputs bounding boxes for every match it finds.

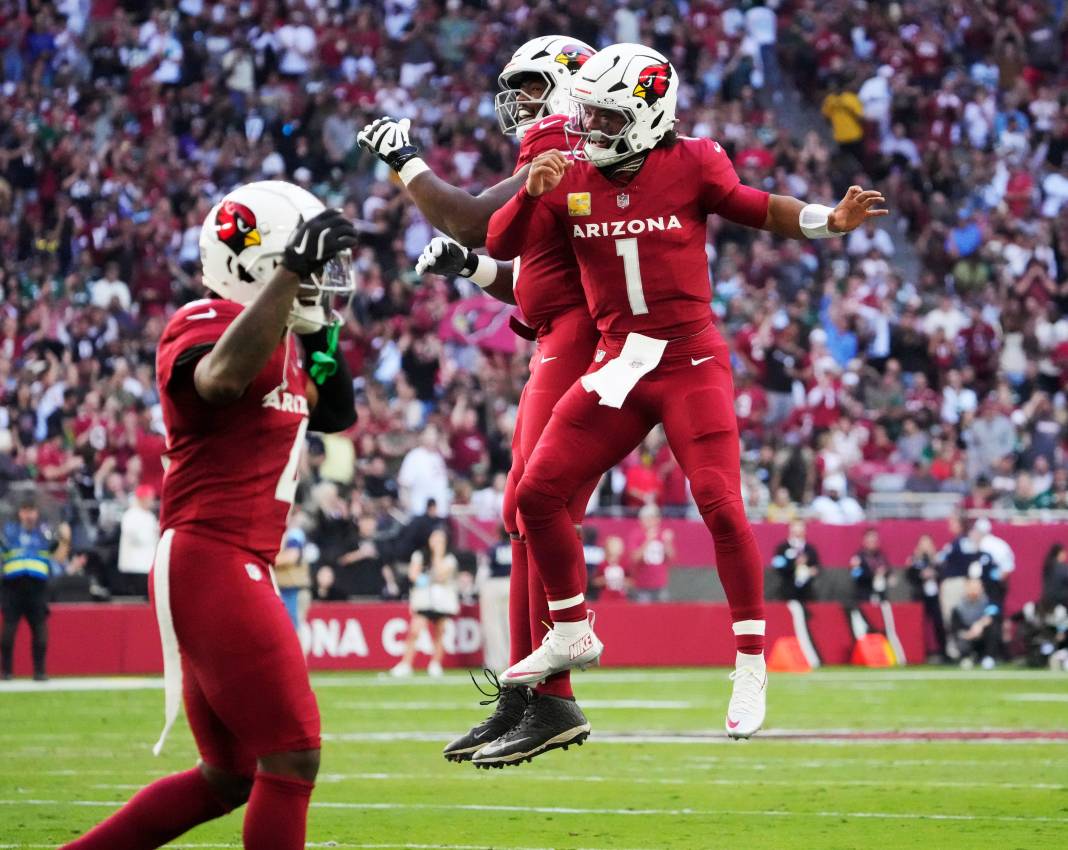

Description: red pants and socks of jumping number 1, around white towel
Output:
[516,325,764,621]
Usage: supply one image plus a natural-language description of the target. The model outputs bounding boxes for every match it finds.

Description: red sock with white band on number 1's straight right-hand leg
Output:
[705,502,764,655]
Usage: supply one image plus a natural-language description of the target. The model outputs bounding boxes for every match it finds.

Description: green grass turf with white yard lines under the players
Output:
[0,668,1068,850]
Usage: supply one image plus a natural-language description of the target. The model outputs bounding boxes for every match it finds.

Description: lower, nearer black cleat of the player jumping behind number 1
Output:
[471,693,590,768]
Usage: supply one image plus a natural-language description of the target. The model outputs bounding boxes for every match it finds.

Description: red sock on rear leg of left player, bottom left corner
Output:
[63,768,232,850]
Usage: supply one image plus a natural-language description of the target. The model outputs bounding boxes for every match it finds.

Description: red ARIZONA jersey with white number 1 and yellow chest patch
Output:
[486,138,767,339]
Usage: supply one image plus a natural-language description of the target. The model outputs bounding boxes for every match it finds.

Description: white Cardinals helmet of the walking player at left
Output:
[200,180,356,333]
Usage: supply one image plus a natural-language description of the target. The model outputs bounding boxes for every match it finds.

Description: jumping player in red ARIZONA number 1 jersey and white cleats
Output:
[486,44,885,737]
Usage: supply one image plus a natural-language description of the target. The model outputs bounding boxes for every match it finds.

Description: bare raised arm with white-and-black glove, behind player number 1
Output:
[357,117,527,248]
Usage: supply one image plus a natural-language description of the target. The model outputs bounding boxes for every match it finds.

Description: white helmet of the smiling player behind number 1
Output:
[493,35,596,139]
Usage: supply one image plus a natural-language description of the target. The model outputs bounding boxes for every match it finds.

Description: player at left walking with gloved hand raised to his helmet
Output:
[66,182,357,850]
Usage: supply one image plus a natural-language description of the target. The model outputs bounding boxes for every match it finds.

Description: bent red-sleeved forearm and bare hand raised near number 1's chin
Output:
[486,151,572,259]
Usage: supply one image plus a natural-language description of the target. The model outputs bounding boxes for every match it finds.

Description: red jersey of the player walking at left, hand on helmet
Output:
[156,299,309,562]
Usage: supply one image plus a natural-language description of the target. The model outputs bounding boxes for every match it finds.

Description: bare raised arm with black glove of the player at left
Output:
[193,209,357,405]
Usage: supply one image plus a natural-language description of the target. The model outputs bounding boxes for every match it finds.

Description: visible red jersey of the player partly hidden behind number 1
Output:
[514,115,586,328]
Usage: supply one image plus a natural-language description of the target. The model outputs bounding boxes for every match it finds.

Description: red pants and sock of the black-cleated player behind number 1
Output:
[503,308,600,695]
